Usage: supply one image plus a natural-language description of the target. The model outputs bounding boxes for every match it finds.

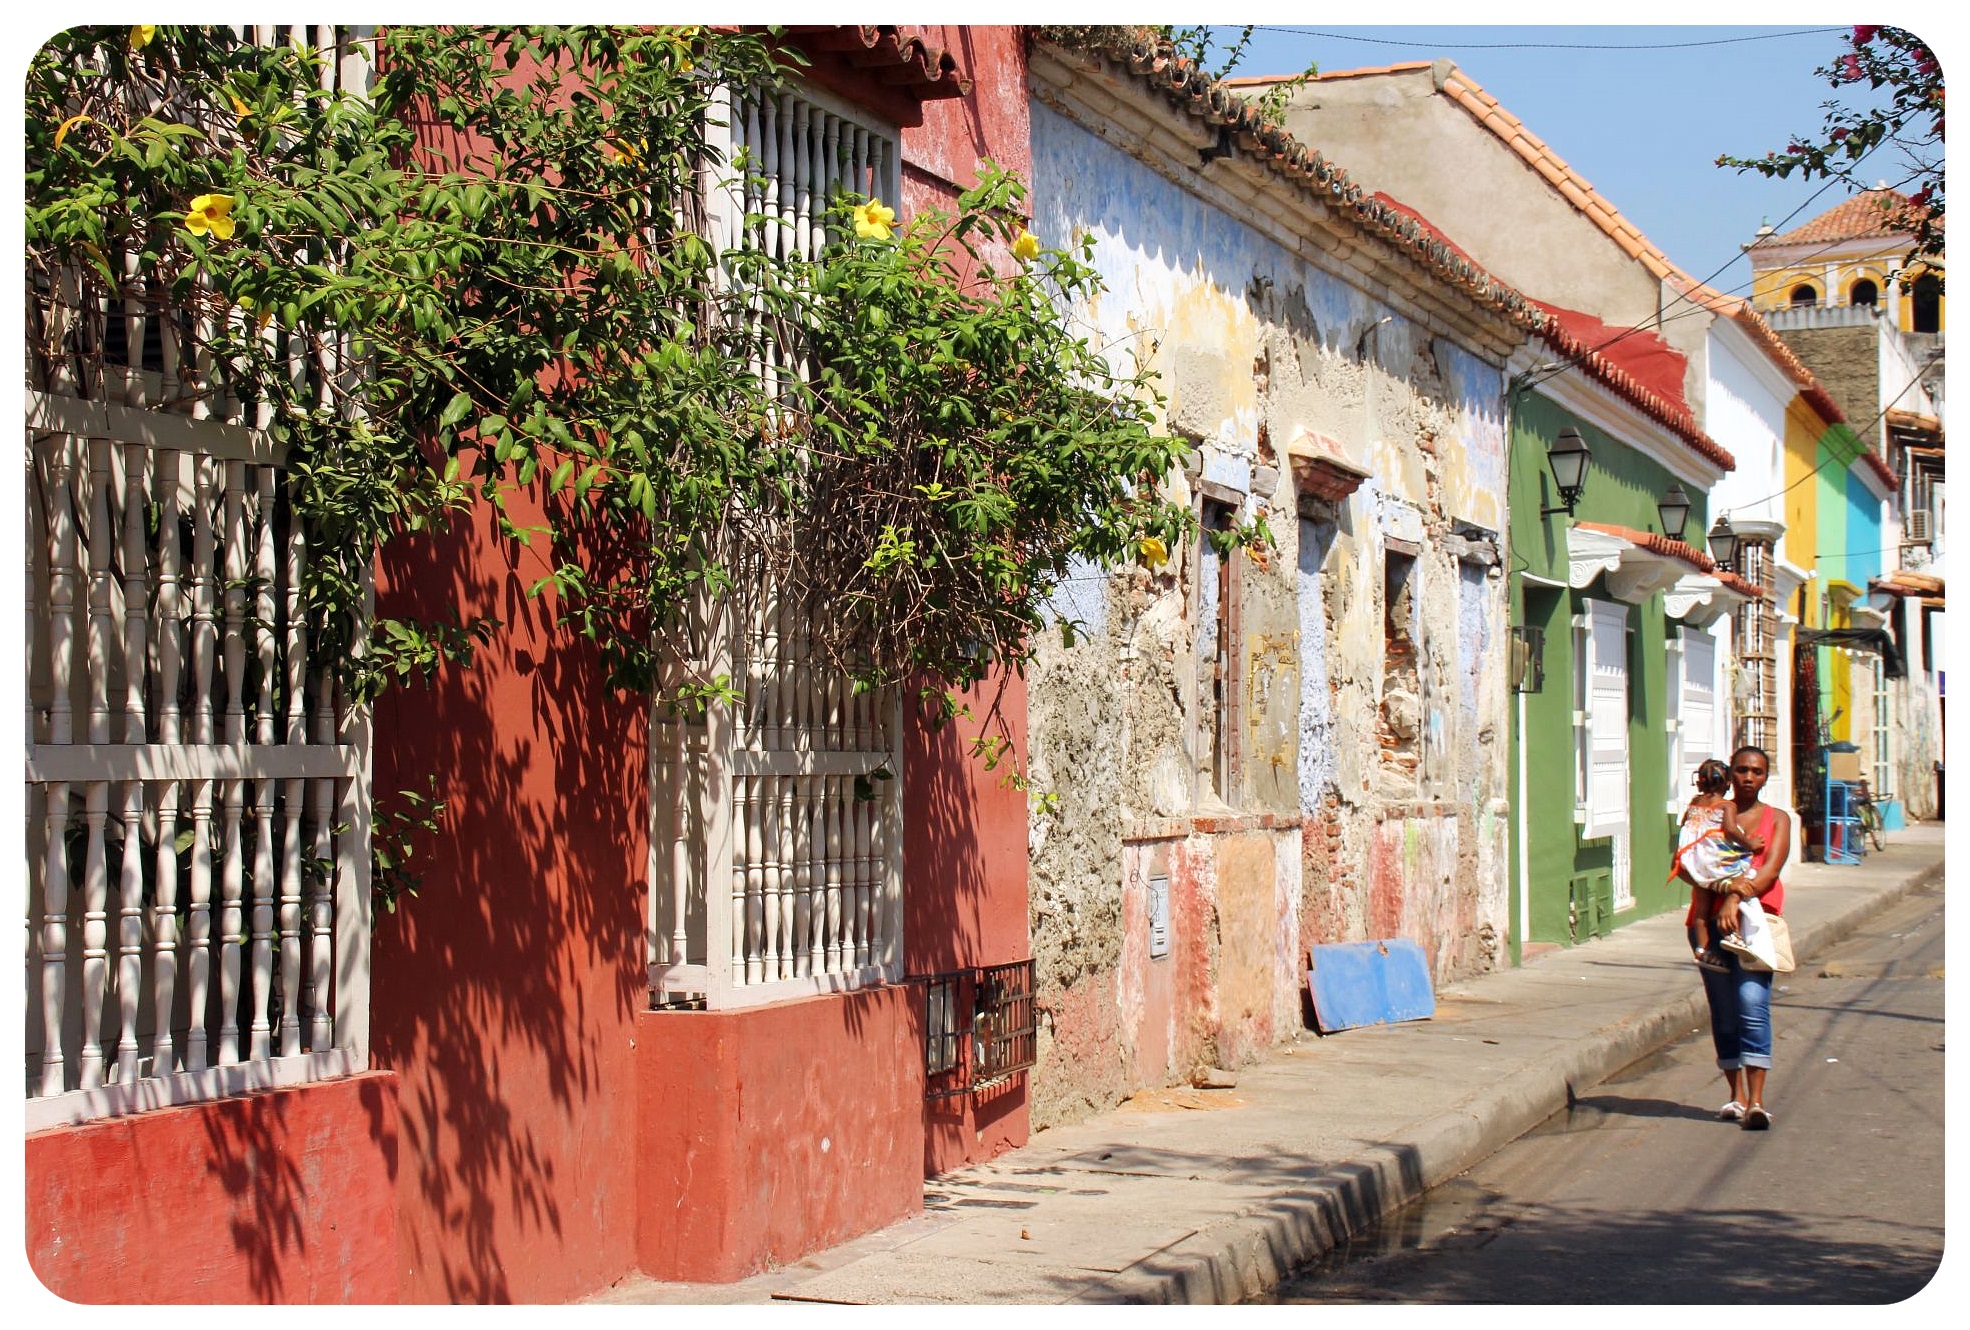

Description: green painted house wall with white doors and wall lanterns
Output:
[1507,394,1708,962]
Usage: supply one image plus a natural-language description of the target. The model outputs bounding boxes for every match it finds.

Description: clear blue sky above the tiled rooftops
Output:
[1214,25,1950,303]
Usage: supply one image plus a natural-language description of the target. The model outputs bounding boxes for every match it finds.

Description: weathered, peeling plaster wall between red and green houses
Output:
[1028,106,1505,1123]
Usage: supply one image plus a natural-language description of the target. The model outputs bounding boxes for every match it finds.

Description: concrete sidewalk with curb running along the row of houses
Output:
[591,824,1942,1302]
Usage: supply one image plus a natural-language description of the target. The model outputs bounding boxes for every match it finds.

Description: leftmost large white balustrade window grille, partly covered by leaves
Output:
[24,28,370,1131]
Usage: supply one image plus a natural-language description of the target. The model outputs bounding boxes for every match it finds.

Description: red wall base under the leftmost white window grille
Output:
[24,1072,398,1302]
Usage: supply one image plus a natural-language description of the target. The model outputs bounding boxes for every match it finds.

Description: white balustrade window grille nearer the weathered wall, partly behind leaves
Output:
[648,80,902,1007]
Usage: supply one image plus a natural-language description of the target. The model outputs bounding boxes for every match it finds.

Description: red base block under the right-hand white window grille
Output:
[634,985,924,1281]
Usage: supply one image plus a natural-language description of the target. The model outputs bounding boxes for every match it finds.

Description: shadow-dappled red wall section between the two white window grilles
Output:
[370,484,648,1302]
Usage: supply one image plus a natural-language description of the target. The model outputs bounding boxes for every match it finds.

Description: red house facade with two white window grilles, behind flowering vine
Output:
[26,26,1030,1302]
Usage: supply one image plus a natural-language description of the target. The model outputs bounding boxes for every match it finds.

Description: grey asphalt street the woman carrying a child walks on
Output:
[1265,881,1944,1302]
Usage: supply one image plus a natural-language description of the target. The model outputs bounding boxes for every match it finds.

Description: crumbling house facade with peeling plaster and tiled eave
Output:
[1028,45,1544,1121]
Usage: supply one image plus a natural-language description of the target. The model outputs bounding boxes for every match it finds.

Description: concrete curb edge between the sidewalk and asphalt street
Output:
[1085,861,1942,1304]
